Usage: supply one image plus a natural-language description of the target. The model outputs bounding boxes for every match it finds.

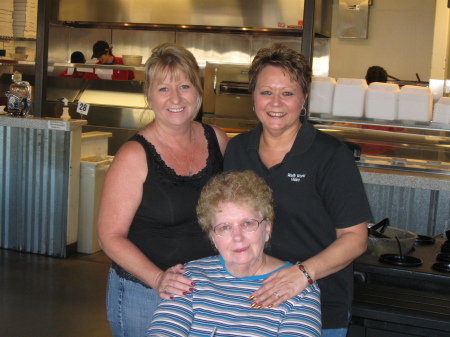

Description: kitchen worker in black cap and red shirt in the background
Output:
[83,41,134,81]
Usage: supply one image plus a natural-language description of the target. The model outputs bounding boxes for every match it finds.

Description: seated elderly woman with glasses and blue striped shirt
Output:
[146,171,321,337]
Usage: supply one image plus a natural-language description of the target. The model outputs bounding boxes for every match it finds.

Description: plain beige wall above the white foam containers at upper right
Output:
[329,0,436,81]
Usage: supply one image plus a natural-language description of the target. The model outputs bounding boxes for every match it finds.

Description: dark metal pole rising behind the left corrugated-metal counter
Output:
[33,0,50,118]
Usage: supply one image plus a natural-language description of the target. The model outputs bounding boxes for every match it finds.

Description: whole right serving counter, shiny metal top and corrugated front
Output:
[313,119,450,235]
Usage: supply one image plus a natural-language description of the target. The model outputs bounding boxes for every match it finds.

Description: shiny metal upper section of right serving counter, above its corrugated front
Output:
[313,120,450,175]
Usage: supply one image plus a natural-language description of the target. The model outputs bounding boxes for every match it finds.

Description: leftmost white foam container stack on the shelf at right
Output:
[331,78,368,117]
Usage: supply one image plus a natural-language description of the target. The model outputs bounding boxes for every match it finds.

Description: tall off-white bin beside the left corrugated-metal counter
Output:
[77,155,114,254]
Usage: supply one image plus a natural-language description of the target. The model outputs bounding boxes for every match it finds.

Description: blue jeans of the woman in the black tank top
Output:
[106,269,162,337]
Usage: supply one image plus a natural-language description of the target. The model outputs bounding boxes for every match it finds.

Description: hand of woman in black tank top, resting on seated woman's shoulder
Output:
[154,264,195,300]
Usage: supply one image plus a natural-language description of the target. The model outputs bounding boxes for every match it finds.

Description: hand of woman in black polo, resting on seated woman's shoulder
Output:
[249,265,308,309]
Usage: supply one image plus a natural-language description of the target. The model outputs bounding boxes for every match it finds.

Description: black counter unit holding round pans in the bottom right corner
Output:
[348,238,450,337]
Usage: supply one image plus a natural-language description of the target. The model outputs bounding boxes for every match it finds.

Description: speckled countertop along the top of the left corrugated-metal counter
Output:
[0,115,87,131]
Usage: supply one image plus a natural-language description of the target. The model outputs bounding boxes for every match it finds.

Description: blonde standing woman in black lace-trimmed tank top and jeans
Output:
[98,43,228,337]
